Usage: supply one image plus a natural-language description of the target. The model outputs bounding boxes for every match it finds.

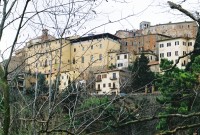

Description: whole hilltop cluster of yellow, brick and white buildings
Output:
[2,21,198,95]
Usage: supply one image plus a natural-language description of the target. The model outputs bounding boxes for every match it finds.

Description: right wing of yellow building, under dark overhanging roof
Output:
[71,33,120,73]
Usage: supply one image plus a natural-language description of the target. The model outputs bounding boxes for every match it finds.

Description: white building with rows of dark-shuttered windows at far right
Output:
[158,37,195,69]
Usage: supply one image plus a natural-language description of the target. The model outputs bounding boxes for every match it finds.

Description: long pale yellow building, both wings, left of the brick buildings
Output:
[25,30,120,90]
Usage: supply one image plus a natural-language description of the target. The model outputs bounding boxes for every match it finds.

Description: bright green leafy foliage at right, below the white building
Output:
[156,56,200,131]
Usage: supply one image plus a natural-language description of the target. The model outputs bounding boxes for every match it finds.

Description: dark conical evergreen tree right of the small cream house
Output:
[129,53,154,91]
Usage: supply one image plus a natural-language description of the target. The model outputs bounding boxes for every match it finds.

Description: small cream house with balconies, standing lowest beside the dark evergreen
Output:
[95,70,129,95]
